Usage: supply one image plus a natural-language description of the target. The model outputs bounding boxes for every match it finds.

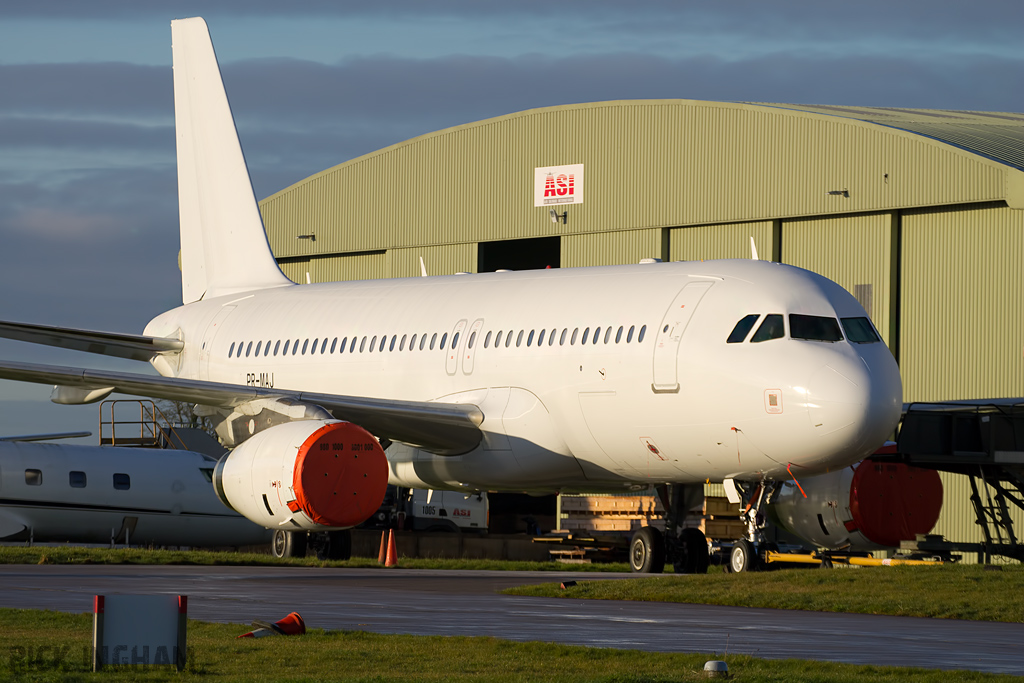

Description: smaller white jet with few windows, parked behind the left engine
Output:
[0,434,270,547]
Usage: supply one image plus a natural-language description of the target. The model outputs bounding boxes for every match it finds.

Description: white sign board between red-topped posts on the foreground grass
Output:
[92,595,188,671]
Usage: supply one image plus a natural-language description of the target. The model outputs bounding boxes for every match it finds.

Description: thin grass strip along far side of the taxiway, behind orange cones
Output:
[0,546,630,571]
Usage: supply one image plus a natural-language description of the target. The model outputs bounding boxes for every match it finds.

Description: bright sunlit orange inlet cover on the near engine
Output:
[293,422,388,527]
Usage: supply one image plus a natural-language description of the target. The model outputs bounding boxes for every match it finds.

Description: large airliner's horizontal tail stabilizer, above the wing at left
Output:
[0,321,184,360]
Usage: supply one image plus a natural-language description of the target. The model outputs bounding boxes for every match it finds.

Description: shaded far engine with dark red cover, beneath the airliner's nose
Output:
[768,459,942,552]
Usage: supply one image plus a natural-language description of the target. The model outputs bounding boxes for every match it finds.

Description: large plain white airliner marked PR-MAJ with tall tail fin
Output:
[0,18,902,571]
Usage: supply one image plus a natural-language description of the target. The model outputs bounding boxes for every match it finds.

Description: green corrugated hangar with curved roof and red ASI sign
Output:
[260,99,1024,561]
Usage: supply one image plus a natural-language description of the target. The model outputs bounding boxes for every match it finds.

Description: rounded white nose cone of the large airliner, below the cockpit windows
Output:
[807,345,903,461]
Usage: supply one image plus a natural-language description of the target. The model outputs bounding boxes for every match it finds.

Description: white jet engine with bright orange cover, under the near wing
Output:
[213,420,388,531]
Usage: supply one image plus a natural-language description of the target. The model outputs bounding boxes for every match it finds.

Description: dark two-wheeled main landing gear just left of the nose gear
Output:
[629,484,709,573]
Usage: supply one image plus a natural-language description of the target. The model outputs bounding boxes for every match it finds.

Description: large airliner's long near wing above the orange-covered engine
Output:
[0,360,483,455]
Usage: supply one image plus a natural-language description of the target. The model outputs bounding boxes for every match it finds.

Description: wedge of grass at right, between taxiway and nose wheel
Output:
[504,564,1024,623]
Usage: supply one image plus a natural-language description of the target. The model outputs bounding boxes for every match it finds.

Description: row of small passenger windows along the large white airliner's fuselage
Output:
[227,325,647,358]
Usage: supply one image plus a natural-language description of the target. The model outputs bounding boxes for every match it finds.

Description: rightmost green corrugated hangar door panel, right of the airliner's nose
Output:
[900,208,1024,401]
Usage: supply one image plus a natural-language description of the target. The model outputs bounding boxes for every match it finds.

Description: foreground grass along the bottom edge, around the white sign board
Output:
[0,609,1024,683]
